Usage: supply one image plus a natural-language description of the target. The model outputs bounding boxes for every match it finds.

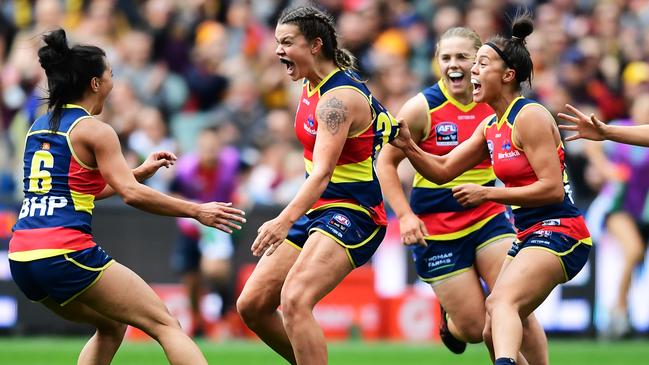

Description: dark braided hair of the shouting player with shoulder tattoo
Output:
[278,6,356,69]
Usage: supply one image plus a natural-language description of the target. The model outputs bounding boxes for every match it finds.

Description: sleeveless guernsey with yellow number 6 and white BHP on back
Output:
[9,105,106,261]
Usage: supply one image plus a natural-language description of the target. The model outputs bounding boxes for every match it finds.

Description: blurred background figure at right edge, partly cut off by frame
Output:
[586,93,649,339]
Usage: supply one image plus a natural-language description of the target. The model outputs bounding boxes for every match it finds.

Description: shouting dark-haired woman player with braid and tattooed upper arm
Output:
[237,7,397,365]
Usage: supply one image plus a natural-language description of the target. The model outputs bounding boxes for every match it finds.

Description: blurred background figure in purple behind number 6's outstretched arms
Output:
[171,127,239,336]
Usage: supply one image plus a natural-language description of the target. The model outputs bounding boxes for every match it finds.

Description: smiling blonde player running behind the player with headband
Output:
[377,27,547,364]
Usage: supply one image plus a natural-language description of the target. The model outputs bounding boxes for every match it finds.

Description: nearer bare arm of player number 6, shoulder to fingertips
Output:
[78,118,245,233]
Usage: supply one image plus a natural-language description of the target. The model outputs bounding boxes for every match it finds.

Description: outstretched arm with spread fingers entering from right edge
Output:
[558,104,649,147]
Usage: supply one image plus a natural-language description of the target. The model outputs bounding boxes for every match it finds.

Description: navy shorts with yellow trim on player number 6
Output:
[9,246,115,306]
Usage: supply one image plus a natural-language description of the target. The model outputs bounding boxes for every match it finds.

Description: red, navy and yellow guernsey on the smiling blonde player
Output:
[410,80,505,240]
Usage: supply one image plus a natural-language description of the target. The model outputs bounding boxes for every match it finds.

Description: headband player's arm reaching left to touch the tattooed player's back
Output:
[390,120,489,185]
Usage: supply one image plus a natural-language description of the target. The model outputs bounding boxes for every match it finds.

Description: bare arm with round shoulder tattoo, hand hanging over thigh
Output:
[251,89,362,256]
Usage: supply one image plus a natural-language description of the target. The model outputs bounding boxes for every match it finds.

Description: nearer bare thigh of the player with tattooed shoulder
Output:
[282,232,354,305]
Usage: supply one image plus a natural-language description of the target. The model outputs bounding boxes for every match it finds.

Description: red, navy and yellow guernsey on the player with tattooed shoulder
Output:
[295,69,398,225]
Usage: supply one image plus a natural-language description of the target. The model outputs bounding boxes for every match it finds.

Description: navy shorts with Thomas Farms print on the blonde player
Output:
[411,212,516,283]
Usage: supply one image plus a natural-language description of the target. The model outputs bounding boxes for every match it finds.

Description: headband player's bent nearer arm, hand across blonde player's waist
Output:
[453,105,565,207]
